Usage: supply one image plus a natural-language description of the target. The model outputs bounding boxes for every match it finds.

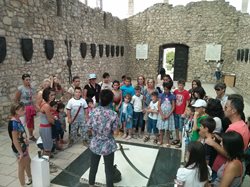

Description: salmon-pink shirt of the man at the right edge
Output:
[226,120,250,150]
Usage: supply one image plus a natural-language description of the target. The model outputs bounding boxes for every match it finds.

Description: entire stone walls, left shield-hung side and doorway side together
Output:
[0,0,250,120]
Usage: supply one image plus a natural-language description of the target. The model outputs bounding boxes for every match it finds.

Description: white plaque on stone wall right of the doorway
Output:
[205,44,221,61]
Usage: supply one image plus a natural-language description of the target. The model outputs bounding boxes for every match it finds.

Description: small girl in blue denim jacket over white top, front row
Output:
[120,94,133,140]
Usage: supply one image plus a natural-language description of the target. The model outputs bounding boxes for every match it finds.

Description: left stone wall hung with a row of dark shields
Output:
[0,0,127,120]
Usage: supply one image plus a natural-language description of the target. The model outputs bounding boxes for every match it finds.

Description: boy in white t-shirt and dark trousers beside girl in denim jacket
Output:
[131,86,143,138]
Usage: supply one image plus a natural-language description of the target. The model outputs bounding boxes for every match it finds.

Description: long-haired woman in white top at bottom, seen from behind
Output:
[175,142,211,187]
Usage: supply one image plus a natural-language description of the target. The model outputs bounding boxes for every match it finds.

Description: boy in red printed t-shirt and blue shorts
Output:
[172,80,190,148]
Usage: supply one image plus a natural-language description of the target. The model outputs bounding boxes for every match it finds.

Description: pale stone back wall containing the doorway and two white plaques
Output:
[127,0,250,91]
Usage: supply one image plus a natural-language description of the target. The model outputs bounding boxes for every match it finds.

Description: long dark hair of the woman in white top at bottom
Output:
[185,141,208,182]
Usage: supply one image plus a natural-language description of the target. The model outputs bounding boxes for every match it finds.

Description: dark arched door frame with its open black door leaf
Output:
[158,43,189,81]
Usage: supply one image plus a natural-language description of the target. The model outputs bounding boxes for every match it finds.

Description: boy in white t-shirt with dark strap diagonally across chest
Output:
[66,87,88,146]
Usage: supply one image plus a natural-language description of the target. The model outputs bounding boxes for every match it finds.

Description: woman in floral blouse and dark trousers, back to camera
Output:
[87,90,119,187]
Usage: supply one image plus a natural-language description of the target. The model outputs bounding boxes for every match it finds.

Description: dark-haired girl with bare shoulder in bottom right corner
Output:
[214,131,245,187]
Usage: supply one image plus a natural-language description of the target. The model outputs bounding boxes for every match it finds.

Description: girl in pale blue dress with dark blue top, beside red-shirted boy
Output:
[156,82,176,147]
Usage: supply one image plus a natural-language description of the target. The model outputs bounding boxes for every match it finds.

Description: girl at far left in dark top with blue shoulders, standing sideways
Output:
[8,103,32,187]
